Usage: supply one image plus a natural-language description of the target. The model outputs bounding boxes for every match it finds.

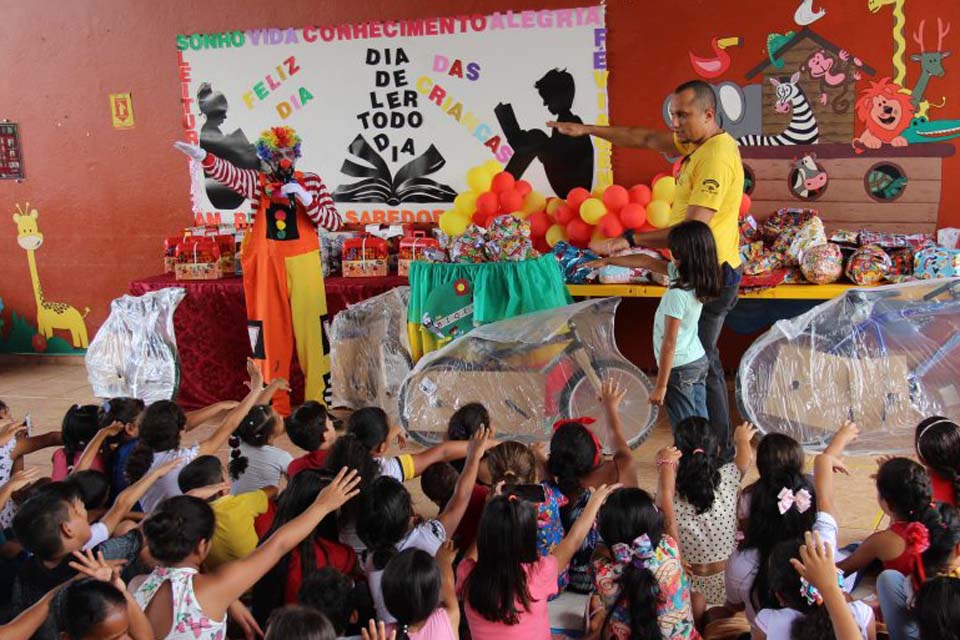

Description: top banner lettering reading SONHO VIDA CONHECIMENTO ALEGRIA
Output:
[177,7,603,51]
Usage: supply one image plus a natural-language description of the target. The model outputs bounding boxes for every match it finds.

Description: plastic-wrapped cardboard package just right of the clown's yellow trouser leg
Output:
[330,287,413,421]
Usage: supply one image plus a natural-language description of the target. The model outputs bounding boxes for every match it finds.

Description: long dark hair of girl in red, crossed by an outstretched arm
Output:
[253,469,339,622]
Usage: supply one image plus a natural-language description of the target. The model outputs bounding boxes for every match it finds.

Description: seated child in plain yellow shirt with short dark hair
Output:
[177,456,277,571]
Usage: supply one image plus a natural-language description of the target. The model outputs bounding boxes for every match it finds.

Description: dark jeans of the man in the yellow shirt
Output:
[698,263,743,462]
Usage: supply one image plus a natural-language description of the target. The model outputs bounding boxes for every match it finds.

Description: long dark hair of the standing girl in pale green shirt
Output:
[667,220,723,302]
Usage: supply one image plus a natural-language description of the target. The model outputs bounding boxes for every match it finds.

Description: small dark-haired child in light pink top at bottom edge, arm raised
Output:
[381,540,460,640]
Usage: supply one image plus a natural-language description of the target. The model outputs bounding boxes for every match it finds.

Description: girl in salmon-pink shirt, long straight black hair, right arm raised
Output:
[457,485,620,640]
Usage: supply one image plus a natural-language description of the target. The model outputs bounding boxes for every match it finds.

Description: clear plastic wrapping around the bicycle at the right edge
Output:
[737,278,960,454]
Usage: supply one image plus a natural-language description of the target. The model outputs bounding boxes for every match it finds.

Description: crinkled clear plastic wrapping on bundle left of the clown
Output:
[84,287,186,404]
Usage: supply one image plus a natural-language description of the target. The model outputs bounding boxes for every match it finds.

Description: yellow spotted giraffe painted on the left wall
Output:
[6,203,90,351]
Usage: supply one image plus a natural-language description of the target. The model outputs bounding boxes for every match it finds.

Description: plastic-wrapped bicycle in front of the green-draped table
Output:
[400,298,657,452]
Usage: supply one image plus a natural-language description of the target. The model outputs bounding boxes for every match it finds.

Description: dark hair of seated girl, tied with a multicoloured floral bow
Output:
[597,489,663,640]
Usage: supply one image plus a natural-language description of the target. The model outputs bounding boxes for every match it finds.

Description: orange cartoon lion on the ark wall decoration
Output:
[853,78,914,149]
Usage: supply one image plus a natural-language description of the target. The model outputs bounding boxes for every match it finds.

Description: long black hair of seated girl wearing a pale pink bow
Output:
[740,469,817,611]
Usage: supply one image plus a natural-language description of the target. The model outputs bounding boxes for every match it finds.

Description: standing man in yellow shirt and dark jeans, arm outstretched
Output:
[547,80,743,461]
